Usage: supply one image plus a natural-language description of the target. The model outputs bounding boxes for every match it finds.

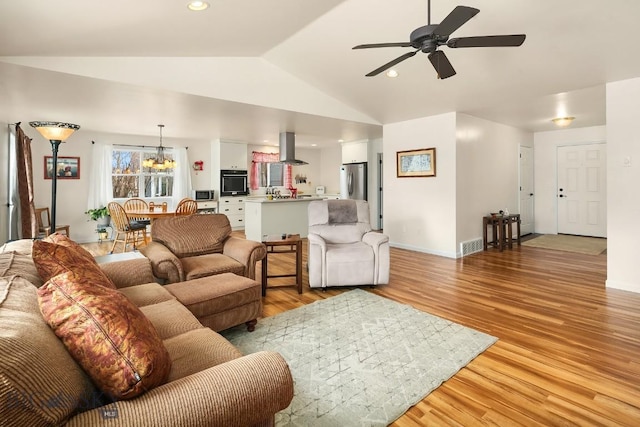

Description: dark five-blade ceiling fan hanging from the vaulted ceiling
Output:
[353,0,526,79]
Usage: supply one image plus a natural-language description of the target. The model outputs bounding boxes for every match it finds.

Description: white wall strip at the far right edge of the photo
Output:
[607,78,640,292]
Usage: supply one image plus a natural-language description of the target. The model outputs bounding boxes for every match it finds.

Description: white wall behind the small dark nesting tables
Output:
[456,114,533,252]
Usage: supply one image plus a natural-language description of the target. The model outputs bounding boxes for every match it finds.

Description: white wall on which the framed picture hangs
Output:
[383,113,456,258]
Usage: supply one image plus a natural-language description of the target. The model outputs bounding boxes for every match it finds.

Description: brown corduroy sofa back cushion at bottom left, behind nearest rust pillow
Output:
[0,277,102,426]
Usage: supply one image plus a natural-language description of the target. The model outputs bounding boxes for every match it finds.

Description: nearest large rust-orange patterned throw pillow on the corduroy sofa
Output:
[38,271,171,399]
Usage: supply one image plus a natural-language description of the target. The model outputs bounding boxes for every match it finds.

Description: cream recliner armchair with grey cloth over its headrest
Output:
[307,200,389,288]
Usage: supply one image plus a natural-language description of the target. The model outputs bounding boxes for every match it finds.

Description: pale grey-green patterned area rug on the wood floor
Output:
[222,289,497,427]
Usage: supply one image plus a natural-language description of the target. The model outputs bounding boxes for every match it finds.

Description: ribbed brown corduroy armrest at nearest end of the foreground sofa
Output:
[68,351,293,427]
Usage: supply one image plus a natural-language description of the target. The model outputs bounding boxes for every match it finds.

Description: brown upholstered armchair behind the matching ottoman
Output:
[140,214,266,283]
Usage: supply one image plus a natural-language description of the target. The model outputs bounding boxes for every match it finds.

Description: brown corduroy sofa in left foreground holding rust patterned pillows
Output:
[0,240,293,426]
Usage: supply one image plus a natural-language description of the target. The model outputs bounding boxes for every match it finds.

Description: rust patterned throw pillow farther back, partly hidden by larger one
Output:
[32,240,115,289]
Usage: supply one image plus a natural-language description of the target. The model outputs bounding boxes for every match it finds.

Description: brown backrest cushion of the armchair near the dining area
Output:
[151,214,231,258]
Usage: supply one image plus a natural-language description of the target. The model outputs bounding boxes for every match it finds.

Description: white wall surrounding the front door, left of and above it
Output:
[533,126,607,234]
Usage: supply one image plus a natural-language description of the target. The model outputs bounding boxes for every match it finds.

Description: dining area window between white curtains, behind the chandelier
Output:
[111,148,173,199]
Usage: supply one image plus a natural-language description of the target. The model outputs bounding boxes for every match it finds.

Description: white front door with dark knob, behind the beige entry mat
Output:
[557,144,607,237]
